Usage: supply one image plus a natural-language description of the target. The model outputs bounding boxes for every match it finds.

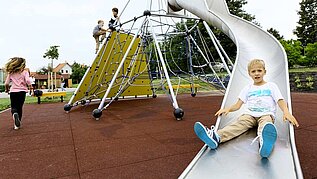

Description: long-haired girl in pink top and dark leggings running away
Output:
[5,57,32,130]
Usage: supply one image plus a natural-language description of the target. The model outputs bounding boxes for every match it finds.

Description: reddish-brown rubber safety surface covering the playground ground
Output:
[0,93,317,179]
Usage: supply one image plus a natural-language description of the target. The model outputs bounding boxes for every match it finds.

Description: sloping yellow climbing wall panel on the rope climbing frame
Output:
[70,32,152,103]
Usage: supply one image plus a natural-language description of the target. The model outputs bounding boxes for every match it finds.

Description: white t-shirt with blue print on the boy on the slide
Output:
[239,82,284,117]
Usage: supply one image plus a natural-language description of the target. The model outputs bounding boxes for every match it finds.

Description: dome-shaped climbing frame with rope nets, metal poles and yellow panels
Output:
[64,1,232,119]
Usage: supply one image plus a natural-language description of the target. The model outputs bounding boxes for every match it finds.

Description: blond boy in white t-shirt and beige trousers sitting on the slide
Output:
[194,59,298,158]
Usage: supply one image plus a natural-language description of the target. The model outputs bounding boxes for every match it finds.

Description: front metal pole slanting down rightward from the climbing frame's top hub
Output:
[150,19,179,109]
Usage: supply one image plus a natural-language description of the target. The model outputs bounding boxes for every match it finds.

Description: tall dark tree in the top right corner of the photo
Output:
[294,0,317,47]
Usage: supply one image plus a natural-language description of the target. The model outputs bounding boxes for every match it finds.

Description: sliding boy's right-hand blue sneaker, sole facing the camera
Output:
[259,122,277,158]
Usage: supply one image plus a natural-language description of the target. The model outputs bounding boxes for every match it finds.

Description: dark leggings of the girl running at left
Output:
[10,91,26,120]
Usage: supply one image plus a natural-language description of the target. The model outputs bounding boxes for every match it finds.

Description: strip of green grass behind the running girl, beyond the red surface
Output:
[0,92,73,111]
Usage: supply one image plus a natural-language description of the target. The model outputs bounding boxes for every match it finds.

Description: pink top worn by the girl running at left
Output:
[5,71,31,92]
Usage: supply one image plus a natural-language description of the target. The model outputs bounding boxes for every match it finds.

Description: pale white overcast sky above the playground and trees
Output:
[0,0,300,72]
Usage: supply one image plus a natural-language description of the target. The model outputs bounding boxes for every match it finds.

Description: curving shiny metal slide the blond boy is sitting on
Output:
[169,0,303,179]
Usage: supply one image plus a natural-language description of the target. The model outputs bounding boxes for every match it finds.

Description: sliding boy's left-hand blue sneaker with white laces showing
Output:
[194,122,220,149]
